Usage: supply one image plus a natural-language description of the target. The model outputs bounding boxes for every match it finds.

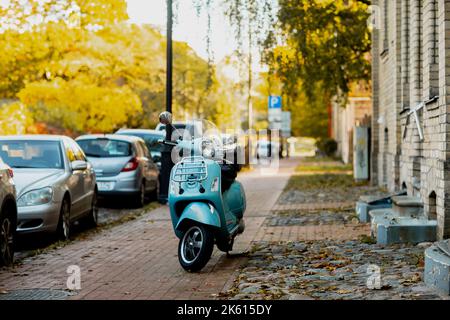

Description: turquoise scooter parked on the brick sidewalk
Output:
[160,112,246,272]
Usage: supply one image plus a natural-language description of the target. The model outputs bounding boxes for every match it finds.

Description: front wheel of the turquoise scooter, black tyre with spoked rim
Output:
[178,225,214,272]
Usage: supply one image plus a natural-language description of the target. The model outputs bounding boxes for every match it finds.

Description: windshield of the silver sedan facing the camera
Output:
[0,140,64,169]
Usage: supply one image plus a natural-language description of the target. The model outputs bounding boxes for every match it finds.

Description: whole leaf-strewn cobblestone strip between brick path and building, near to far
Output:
[221,160,447,300]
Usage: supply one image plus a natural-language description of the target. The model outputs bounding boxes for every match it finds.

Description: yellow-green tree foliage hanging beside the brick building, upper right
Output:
[273,0,371,98]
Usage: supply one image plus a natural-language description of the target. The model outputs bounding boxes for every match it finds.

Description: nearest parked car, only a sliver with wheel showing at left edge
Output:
[0,159,17,266]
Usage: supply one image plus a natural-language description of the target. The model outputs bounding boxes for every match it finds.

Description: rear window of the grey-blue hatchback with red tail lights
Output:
[77,139,132,158]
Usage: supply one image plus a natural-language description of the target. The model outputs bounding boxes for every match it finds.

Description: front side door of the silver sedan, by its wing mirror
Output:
[64,139,85,219]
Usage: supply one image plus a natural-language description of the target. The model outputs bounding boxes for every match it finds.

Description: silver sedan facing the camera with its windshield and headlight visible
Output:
[0,135,98,240]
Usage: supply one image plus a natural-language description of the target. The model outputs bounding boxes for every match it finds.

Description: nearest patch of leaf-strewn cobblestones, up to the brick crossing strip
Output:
[223,240,441,300]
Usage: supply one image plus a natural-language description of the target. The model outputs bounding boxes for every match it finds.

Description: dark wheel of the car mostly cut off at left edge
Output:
[0,206,16,266]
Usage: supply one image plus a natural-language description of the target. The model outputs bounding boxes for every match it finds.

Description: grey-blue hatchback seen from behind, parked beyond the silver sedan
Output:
[76,135,159,207]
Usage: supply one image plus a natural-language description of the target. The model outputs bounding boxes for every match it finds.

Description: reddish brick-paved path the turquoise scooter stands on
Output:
[0,160,296,299]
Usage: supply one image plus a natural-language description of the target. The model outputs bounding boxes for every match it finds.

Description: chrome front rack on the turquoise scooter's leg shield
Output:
[173,157,208,182]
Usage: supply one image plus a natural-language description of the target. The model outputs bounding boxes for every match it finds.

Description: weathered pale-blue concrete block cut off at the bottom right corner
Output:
[424,240,450,295]
